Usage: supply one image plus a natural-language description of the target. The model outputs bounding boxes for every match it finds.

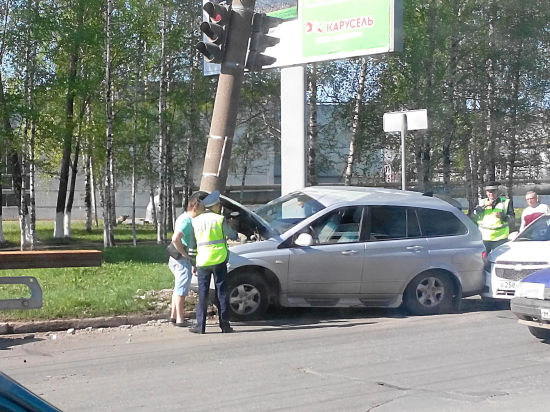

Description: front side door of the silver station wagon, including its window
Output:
[288,206,365,298]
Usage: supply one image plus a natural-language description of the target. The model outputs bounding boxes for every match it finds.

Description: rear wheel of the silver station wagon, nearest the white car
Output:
[404,272,454,315]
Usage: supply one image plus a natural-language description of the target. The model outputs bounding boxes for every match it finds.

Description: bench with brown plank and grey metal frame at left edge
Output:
[0,250,102,310]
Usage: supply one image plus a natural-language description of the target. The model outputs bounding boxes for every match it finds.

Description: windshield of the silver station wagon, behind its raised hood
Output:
[255,192,325,234]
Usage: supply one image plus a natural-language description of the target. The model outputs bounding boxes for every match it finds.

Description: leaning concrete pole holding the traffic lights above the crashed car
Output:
[200,0,256,193]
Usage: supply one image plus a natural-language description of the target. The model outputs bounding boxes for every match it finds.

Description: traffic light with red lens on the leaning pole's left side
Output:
[196,1,231,63]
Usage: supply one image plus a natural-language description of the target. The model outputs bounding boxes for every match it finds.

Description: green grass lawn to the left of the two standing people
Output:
[0,221,174,322]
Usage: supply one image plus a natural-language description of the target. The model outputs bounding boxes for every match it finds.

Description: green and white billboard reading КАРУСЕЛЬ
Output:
[256,0,403,68]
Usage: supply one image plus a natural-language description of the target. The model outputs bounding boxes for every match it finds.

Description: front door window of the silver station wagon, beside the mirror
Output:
[311,206,363,245]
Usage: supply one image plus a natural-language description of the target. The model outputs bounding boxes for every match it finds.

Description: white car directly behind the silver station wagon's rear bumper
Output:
[481,215,550,299]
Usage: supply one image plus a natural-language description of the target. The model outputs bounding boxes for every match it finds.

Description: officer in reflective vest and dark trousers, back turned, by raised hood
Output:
[189,190,236,334]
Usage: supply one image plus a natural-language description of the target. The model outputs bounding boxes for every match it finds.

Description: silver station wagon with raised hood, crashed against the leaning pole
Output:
[194,186,485,320]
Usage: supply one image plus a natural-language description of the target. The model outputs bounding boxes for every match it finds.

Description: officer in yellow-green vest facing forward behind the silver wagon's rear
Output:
[473,182,515,253]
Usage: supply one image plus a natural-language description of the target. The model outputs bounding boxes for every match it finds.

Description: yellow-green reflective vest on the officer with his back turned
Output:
[193,212,227,266]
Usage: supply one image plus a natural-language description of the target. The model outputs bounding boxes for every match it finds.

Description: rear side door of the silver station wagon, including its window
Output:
[361,206,429,300]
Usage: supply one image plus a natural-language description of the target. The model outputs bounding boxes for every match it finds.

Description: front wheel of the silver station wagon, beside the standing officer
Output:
[228,273,269,320]
